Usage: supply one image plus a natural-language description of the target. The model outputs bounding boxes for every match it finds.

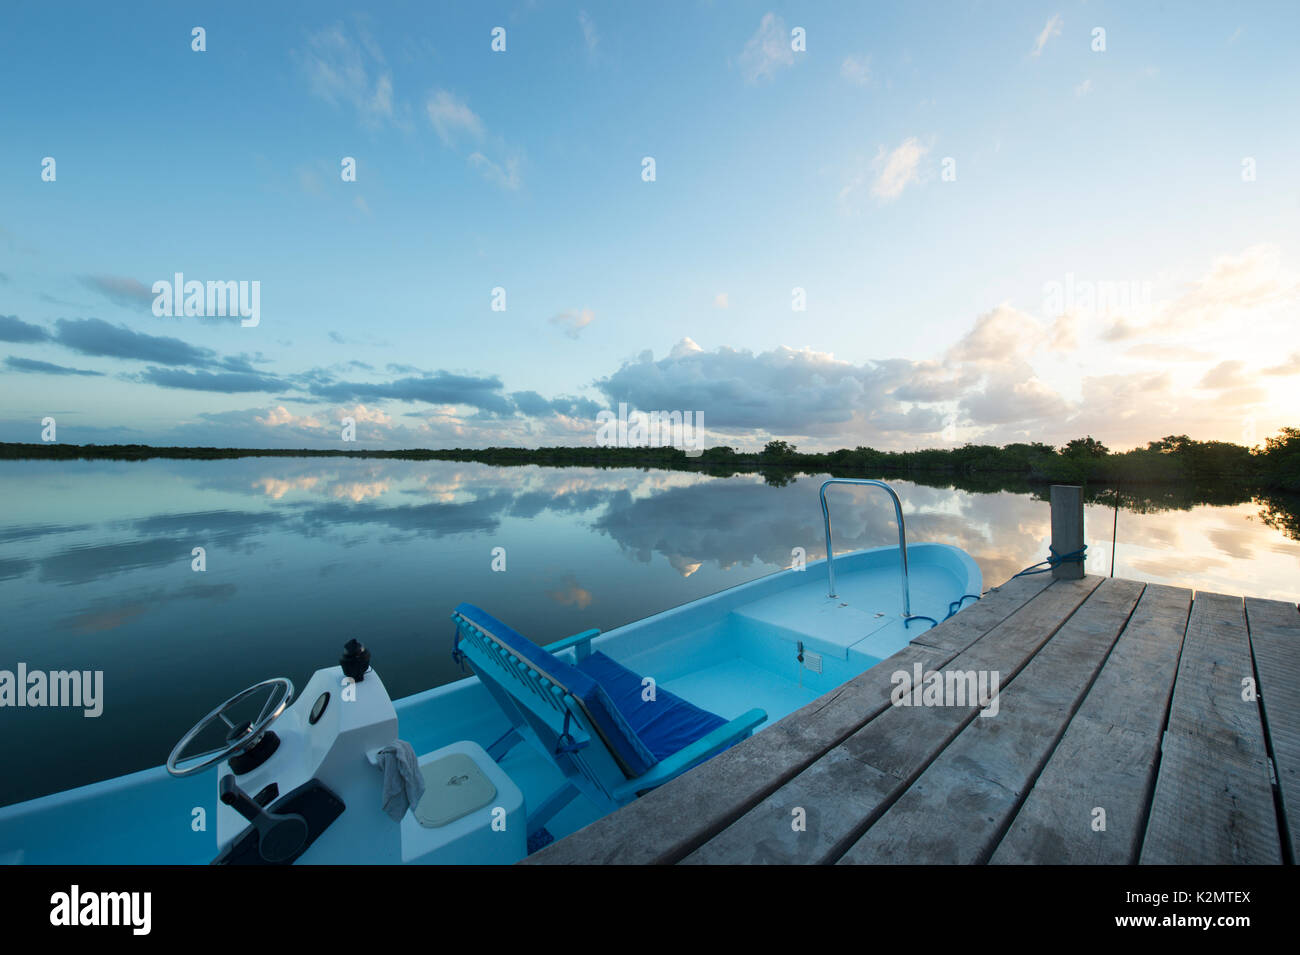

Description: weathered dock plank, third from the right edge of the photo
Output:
[989,583,1192,865]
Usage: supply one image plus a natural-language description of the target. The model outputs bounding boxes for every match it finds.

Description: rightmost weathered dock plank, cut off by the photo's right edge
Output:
[1245,598,1300,861]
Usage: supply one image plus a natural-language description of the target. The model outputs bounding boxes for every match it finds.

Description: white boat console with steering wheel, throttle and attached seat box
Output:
[166,641,527,865]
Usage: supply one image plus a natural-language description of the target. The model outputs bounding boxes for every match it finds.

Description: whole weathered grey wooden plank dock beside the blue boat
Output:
[527,571,1300,864]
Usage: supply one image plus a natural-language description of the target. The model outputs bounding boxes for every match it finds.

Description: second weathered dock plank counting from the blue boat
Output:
[685,574,1101,864]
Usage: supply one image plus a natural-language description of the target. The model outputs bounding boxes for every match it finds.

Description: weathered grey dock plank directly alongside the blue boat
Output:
[524,574,1055,864]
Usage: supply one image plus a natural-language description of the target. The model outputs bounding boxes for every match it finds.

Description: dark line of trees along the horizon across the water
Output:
[0,427,1300,491]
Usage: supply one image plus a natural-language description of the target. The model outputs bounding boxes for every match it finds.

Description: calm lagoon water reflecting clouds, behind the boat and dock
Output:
[0,459,1300,804]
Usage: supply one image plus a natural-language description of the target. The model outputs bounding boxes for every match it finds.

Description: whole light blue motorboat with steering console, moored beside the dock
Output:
[0,478,982,864]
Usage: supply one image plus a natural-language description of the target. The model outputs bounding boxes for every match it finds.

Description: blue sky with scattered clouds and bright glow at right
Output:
[0,0,1300,450]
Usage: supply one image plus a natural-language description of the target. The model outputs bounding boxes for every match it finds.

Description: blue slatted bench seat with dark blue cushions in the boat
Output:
[451,603,767,815]
